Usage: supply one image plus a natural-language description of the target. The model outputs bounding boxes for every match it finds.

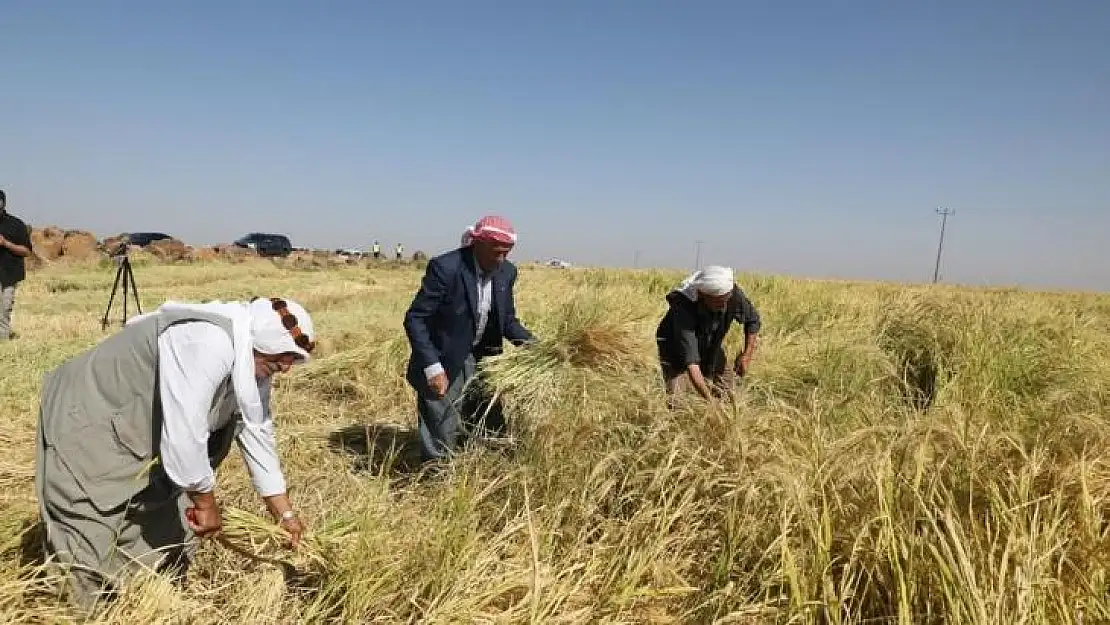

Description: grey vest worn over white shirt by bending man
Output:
[40,312,241,512]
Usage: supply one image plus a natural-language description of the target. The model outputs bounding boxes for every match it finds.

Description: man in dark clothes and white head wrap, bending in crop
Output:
[655,266,760,400]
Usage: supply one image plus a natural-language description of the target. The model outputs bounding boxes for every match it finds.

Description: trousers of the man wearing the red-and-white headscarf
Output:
[416,356,505,462]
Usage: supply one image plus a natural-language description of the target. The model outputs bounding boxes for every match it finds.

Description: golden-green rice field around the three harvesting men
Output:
[0,255,1110,625]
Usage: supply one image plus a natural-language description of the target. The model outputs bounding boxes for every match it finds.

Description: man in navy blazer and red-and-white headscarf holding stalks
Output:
[404,215,535,461]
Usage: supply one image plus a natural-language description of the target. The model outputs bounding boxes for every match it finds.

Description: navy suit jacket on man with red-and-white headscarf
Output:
[405,248,535,390]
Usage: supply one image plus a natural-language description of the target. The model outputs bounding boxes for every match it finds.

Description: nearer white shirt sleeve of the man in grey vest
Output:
[158,322,234,493]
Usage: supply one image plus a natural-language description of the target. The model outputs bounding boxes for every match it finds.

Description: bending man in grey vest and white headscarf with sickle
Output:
[34,299,316,611]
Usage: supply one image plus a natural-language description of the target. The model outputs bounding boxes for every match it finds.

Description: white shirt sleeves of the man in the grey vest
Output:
[158,322,285,496]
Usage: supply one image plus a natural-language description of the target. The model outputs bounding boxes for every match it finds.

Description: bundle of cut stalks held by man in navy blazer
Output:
[478,292,650,411]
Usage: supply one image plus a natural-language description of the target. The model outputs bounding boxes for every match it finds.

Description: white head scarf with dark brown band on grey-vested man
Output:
[128,298,316,426]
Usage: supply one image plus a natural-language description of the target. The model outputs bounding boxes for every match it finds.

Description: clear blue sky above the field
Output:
[0,0,1110,290]
